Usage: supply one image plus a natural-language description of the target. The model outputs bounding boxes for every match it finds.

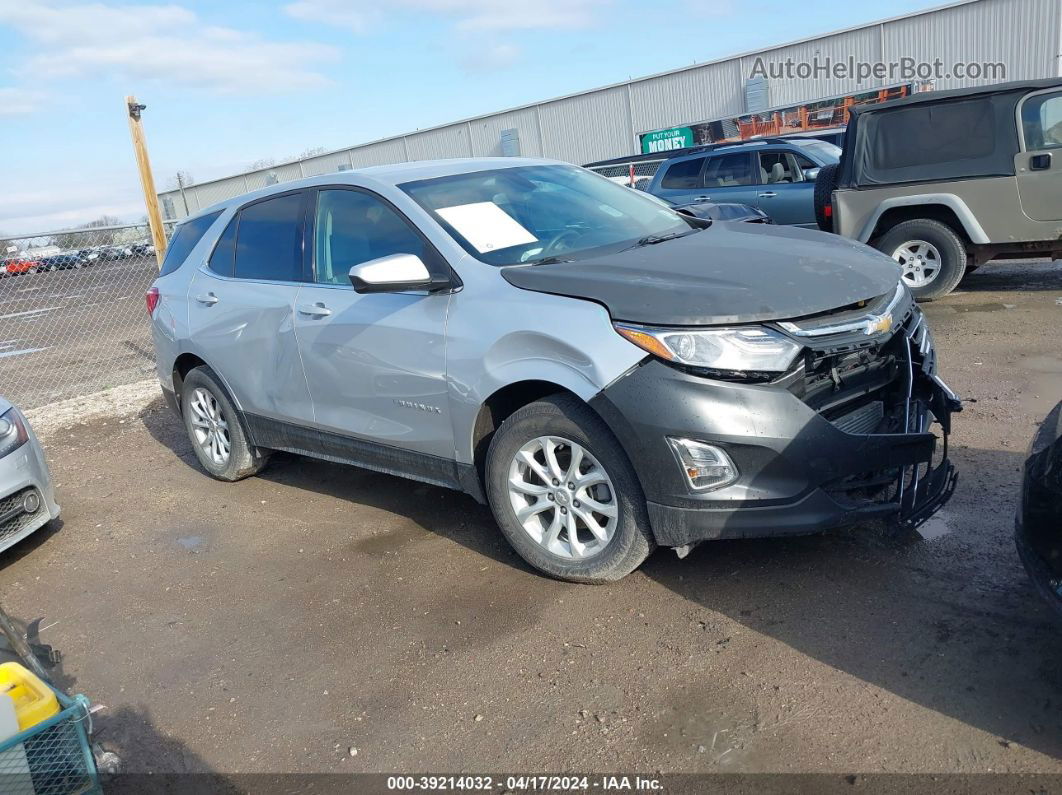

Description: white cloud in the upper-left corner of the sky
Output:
[0,0,339,93]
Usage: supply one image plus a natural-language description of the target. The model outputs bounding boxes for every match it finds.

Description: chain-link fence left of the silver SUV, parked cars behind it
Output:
[0,224,172,409]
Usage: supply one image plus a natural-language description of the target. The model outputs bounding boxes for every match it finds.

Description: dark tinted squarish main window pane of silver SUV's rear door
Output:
[236,193,304,281]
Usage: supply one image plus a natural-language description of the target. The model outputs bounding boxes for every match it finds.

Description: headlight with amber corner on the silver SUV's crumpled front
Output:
[615,323,802,374]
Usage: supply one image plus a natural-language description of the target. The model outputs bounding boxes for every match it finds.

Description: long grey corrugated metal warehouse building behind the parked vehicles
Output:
[159,0,1062,219]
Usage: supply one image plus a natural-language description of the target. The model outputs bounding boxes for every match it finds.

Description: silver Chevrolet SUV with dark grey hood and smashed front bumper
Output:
[148,158,959,582]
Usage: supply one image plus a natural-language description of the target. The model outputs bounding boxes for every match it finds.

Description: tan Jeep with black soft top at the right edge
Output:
[816,77,1062,300]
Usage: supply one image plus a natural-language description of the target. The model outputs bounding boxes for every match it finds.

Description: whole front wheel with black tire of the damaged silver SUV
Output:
[485,395,655,584]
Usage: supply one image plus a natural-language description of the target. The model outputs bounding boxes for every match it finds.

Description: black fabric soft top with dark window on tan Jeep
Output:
[838,77,1062,188]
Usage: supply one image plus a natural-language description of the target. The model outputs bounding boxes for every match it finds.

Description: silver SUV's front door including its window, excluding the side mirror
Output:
[295,188,453,460]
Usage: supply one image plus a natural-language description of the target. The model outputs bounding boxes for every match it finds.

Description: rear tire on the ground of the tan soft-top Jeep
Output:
[874,219,970,301]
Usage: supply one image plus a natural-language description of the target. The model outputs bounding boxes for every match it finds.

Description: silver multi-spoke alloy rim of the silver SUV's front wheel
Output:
[509,436,619,560]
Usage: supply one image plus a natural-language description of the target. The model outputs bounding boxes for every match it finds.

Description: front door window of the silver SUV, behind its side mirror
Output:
[313,190,425,284]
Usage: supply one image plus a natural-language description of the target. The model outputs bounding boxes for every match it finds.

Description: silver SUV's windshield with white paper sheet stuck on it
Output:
[399,166,695,265]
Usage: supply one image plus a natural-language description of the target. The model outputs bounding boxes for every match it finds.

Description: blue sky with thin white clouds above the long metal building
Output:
[0,0,940,235]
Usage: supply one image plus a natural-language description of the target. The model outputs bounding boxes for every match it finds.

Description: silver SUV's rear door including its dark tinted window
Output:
[188,191,313,427]
